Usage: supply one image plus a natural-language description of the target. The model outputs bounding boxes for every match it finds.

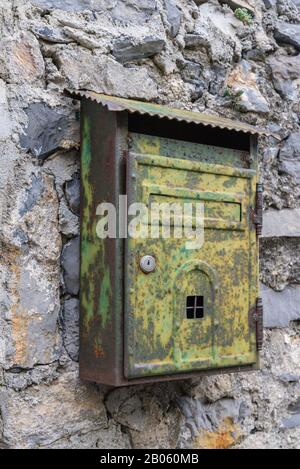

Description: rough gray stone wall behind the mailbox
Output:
[0,0,300,448]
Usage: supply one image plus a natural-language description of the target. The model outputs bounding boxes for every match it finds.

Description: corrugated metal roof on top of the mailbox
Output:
[67,90,279,138]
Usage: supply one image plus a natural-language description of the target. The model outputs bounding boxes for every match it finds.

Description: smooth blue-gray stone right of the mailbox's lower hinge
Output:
[261,284,300,328]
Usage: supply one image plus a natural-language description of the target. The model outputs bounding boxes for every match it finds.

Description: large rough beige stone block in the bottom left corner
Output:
[0,372,107,448]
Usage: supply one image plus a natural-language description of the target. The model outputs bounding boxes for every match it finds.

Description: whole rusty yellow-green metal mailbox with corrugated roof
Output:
[71,91,270,386]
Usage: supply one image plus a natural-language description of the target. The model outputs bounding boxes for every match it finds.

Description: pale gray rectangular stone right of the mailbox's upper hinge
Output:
[262,208,300,238]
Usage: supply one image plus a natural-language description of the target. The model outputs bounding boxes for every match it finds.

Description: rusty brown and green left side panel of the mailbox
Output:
[79,100,123,385]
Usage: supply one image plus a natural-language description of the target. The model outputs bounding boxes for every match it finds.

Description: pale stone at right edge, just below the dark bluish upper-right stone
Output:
[268,55,300,100]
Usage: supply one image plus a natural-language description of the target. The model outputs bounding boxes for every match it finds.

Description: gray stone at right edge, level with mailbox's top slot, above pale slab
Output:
[279,132,300,181]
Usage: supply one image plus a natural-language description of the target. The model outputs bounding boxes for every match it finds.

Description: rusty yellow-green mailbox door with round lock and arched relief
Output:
[124,141,257,378]
